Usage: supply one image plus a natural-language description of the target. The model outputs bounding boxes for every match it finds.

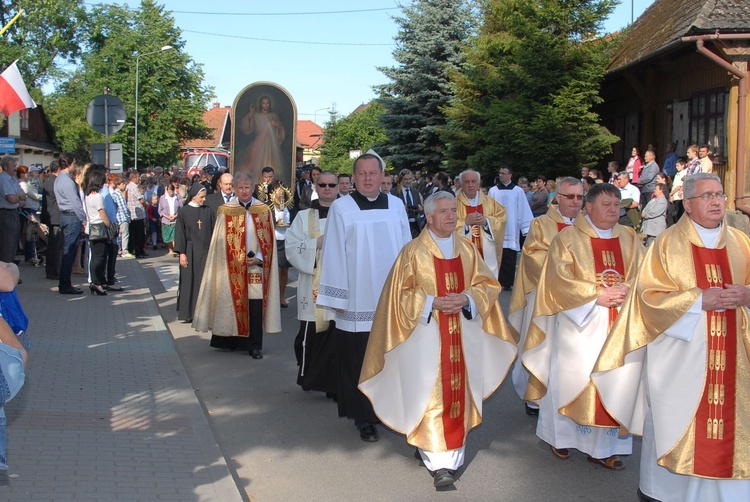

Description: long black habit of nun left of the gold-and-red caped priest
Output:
[174,204,216,320]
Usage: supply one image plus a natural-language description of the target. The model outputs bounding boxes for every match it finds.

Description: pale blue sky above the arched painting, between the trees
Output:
[97,0,653,125]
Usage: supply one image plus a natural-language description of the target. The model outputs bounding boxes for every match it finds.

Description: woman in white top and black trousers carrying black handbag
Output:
[84,170,111,296]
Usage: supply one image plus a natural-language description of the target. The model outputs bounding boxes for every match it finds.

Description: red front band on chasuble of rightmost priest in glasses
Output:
[692,245,737,478]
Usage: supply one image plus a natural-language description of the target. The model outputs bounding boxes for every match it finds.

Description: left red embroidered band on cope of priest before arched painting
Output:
[224,211,250,337]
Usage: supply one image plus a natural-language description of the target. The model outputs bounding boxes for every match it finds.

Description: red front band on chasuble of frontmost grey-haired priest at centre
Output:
[434,257,466,450]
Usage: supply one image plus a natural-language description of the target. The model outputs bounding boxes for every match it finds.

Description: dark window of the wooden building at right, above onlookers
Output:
[689,89,729,162]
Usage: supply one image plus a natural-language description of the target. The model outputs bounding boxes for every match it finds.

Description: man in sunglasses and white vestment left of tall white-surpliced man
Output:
[284,171,339,395]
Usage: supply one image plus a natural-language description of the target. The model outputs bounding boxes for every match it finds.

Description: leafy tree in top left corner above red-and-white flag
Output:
[0,0,84,88]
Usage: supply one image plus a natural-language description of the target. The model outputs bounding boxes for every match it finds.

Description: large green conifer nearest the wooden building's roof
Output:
[443,0,618,179]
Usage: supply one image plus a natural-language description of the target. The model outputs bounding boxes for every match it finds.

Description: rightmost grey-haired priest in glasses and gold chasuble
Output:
[587,173,750,502]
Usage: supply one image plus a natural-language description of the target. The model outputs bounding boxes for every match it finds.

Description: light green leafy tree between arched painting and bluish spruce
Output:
[319,101,386,173]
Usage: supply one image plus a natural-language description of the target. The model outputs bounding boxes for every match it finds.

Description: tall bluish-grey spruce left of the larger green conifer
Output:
[377,0,473,171]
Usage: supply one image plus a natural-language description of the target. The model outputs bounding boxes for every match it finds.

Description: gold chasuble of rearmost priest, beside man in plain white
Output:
[456,191,508,270]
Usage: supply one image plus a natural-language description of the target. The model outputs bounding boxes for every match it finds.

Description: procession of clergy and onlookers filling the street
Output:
[0,145,750,501]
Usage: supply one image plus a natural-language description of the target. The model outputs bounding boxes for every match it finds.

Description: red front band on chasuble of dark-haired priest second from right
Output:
[591,237,625,427]
